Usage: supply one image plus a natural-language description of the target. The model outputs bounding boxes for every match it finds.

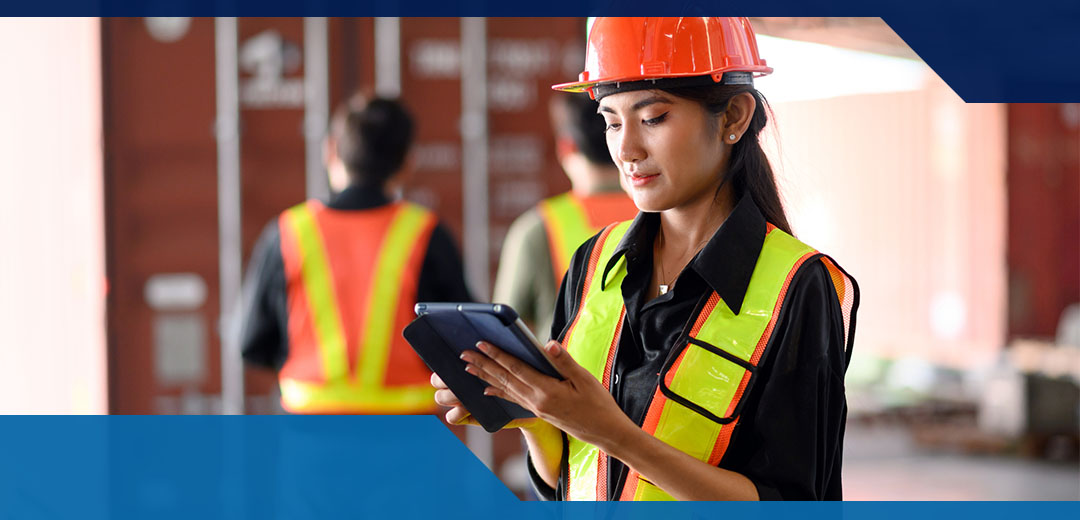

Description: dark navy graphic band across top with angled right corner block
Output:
[6,0,1080,103]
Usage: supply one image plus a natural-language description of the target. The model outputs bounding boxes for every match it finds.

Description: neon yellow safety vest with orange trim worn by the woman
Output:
[564,223,816,501]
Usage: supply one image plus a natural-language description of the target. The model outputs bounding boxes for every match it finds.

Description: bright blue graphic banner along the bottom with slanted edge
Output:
[0,416,1080,520]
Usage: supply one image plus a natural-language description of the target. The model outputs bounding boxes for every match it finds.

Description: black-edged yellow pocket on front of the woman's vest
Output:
[660,337,756,424]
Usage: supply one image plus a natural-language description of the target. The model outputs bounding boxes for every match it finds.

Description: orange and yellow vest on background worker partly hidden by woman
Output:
[539,191,637,285]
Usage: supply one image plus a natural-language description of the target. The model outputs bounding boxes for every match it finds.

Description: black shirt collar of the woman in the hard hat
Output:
[603,195,767,315]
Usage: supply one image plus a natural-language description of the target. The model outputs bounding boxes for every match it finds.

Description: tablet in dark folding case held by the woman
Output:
[403,303,563,432]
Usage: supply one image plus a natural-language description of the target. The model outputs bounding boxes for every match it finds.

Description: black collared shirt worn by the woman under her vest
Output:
[530,197,859,499]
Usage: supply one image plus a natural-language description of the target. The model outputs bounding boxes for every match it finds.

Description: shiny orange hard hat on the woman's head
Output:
[552,16,772,99]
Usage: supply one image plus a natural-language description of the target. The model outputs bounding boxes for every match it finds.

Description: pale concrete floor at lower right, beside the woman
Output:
[843,424,1080,501]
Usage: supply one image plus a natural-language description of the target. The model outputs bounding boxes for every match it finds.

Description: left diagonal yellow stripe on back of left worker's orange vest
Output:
[286,203,348,381]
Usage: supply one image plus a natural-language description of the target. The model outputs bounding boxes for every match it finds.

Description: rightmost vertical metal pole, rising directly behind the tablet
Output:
[461,17,495,467]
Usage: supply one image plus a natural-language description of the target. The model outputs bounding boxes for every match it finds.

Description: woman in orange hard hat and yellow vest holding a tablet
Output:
[432,18,859,501]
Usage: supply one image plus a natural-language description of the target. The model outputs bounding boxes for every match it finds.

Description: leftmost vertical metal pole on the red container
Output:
[214,17,244,414]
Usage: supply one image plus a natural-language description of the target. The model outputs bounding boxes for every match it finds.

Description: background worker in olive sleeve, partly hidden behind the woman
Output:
[494,94,637,336]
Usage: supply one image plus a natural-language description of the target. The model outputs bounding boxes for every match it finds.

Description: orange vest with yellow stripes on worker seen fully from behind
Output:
[278,200,436,414]
